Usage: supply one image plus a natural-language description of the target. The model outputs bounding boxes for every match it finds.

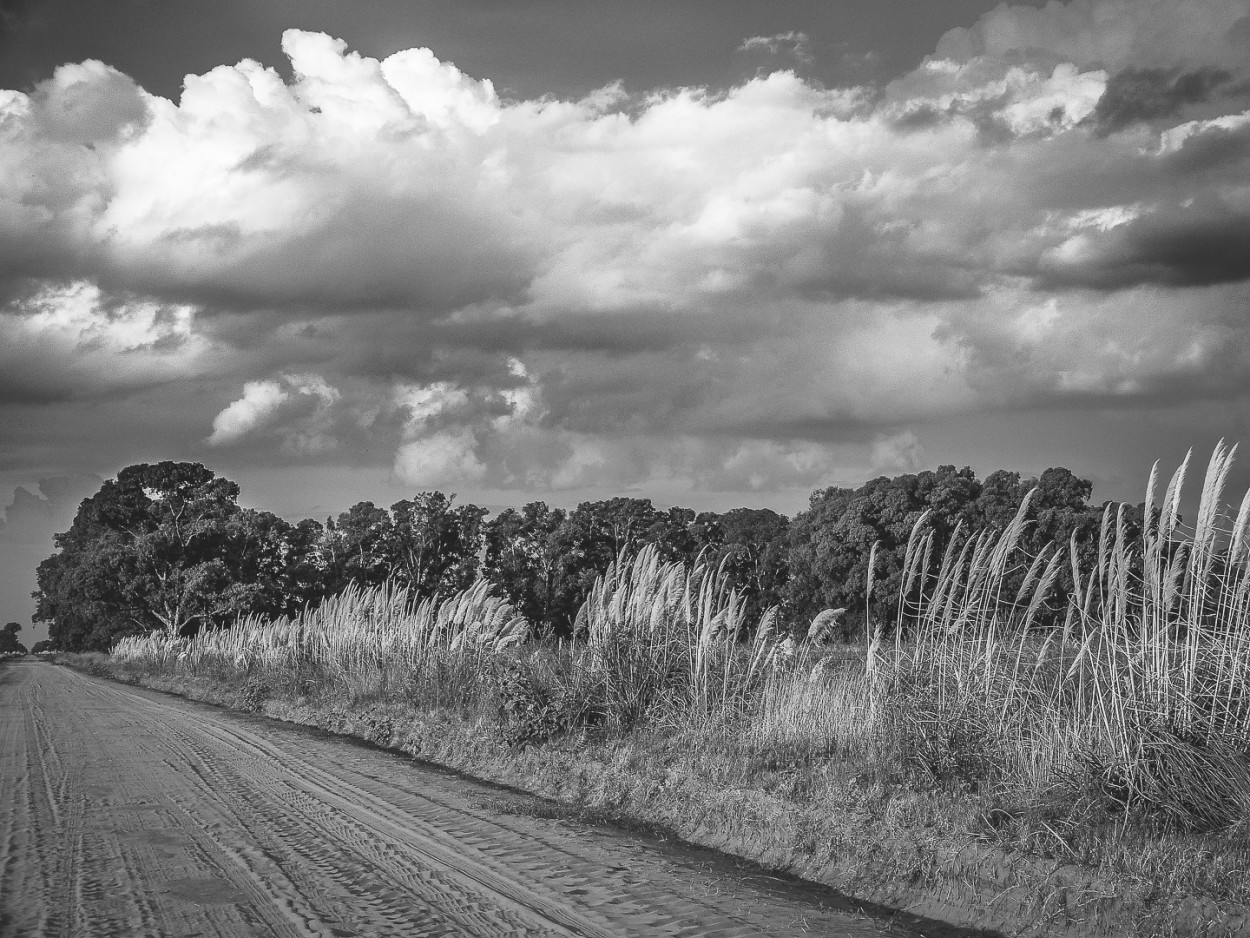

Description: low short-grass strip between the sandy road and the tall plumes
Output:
[60,655,1250,938]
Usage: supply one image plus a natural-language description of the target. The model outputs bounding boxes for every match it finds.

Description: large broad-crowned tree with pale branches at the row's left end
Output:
[35,461,317,650]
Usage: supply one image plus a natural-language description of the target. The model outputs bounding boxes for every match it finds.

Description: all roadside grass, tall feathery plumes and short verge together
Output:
[93,444,1250,934]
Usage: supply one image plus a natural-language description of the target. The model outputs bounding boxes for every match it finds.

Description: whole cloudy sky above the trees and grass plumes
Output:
[0,0,1250,642]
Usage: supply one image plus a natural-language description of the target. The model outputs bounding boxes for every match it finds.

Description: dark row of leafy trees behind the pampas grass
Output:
[34,461,1140,650]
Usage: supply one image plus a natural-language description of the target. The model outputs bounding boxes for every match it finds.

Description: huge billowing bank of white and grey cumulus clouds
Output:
[0,0,1250,500]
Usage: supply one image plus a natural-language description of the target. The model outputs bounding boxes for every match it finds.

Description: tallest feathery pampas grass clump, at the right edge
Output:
[890,443,1250,829]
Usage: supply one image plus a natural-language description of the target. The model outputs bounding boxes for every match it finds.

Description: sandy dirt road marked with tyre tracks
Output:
[0,662,896,938]
